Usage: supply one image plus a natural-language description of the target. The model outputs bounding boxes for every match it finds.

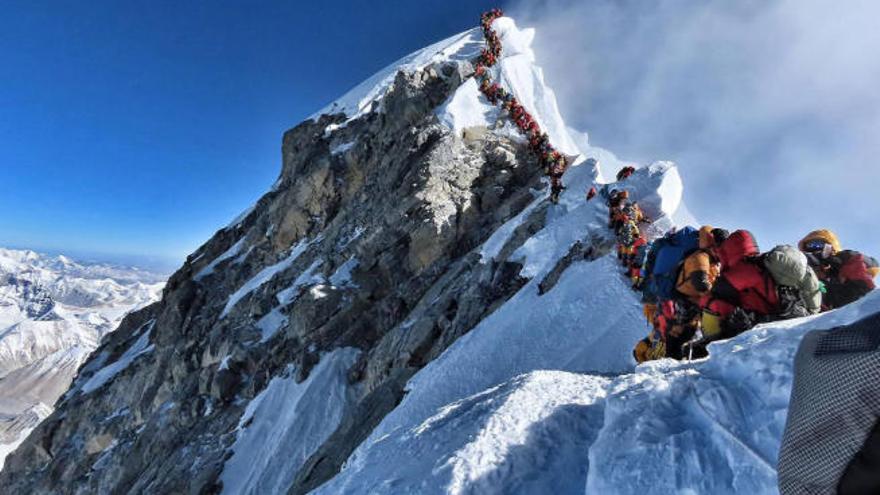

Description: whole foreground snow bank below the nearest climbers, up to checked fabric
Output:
[318,291,880,494]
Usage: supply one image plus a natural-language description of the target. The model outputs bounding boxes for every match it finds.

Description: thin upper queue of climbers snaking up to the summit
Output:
[474,9,573,203]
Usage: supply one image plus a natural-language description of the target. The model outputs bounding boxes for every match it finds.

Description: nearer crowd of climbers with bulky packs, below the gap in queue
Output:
[587,167,880,363]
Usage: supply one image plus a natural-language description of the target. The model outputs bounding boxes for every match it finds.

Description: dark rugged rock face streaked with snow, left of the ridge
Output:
[0,57,556,493]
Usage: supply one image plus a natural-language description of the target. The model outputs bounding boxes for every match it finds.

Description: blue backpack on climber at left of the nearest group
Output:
[644,227,700,302]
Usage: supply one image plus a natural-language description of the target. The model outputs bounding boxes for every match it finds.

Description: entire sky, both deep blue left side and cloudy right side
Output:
[0,0,880,268]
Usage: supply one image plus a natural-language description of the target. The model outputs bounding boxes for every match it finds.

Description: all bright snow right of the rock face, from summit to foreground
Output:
[316,19,868,494]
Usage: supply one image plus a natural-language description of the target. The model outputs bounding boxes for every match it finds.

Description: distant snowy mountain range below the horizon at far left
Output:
[0,249,164,468]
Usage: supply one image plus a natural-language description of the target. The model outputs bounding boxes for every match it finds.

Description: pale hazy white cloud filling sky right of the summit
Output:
[507,0,880,252]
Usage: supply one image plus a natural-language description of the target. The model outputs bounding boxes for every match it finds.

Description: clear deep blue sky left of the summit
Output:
[0,0,494,272]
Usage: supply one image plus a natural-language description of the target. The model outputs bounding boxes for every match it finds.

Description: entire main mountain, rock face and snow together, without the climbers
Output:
[0,18,868,494]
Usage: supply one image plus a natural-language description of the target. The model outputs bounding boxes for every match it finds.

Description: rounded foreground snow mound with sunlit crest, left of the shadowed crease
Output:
[318,371,614,494]
